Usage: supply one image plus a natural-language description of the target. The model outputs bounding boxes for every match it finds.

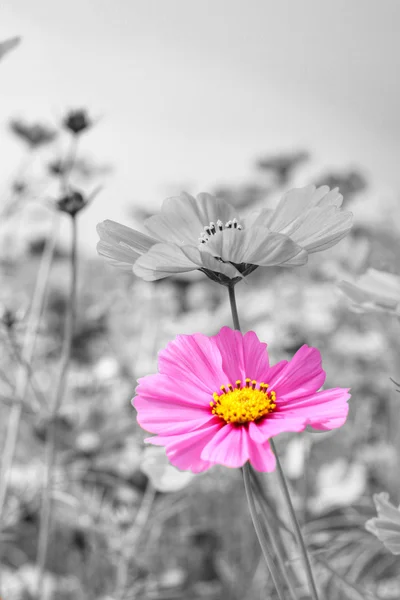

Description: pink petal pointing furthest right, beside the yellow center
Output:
[277,388,350,430]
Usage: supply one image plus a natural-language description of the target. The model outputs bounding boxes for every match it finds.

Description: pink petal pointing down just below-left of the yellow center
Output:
[201,424,253,469]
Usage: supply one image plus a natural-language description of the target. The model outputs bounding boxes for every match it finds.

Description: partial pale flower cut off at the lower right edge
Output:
[365,492,400,554]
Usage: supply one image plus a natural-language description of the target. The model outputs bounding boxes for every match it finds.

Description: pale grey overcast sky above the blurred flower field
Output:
[0,0,400,251]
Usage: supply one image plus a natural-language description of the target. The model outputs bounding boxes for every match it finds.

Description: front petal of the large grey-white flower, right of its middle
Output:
[204,227,307,266]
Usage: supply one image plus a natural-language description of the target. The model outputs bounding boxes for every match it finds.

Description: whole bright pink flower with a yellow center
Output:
[133,327,350,473]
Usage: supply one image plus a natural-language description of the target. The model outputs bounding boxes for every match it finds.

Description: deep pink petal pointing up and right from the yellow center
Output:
[267,345,326,402]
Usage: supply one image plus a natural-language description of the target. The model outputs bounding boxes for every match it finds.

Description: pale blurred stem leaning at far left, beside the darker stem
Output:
[0,213,59,529]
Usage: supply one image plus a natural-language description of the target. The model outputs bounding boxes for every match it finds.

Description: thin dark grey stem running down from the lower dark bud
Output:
[36,217,78,599]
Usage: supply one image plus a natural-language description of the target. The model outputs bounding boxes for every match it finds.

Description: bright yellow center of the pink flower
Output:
[210,379,276,425]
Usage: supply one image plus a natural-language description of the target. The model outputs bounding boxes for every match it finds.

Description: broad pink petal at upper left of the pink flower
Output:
[158,333,226,394]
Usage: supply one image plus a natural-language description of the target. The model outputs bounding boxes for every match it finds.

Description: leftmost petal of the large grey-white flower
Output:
[96,221,156,269]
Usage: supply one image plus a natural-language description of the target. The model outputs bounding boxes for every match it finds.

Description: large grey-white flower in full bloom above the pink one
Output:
[97,186,352,285]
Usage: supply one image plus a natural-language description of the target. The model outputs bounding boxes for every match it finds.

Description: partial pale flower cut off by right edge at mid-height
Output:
[338,269,400,316]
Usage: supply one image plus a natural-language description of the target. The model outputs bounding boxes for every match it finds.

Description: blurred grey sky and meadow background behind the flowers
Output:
[0,0,400,600]
